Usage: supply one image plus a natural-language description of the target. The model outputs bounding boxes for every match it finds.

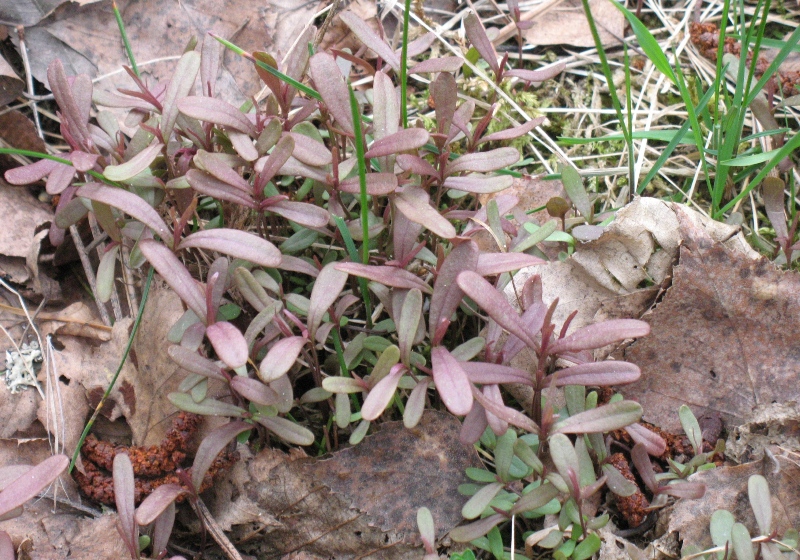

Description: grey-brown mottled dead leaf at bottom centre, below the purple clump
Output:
[313,411,480,538]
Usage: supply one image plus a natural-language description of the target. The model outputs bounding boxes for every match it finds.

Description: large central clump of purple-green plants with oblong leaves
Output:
[0,7,692,557]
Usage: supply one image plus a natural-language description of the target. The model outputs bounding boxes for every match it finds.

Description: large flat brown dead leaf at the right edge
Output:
[623,217,800,431]
